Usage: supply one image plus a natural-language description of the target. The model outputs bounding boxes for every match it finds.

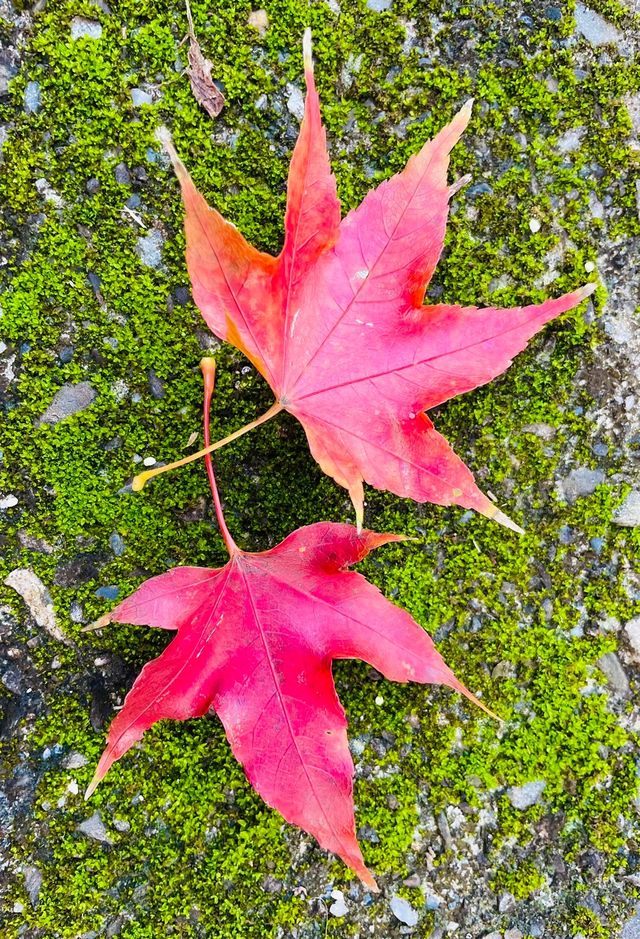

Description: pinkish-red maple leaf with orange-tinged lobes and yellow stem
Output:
[146,31,595,530]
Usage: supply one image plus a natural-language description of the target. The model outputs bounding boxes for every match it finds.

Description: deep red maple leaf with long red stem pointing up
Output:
[87,359,490,889]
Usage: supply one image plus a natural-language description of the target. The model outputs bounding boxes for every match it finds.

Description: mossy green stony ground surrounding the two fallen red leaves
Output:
[0,0,640,939]
